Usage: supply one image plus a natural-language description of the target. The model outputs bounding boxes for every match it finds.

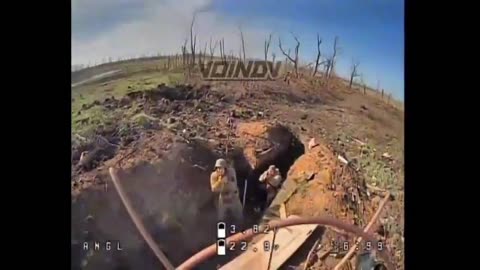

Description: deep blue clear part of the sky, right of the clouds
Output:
[215,0,404,99]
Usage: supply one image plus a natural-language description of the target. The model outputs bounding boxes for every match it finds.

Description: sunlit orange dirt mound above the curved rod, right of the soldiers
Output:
[286,139,367,225]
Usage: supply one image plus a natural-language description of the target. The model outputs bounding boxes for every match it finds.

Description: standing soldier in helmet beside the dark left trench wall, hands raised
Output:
[210,159,243,222]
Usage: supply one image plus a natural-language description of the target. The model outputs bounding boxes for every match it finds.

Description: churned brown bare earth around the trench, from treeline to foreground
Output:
[72,75,403,269]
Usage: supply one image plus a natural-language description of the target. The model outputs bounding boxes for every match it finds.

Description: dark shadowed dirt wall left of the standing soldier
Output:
[72,144,221,269]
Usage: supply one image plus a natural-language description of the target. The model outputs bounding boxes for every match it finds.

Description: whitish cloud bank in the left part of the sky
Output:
[72,0,278,64]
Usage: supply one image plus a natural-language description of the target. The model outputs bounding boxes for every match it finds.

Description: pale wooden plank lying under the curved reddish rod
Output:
[220,216,318,270]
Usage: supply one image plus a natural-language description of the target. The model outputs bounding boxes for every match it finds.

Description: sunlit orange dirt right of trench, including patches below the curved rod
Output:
[285,139,378,269]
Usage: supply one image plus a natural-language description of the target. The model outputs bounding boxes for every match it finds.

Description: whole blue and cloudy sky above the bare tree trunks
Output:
[72,0,404,100]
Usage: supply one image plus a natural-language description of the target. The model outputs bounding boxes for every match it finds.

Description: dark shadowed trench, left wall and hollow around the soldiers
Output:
[71,127,305,270]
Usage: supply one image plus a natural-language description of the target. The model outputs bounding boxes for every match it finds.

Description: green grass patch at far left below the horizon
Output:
[72,69,183,136]
